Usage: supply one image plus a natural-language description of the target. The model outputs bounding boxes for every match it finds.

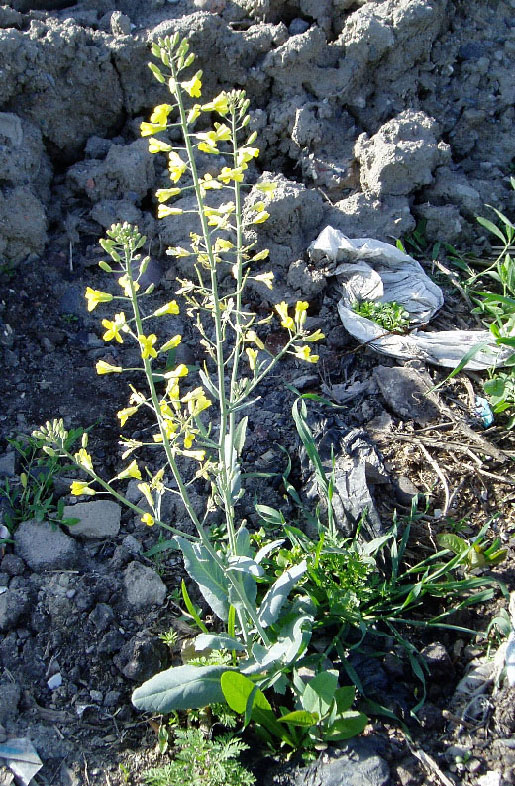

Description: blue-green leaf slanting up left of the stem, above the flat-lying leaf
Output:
[175,537,229,622]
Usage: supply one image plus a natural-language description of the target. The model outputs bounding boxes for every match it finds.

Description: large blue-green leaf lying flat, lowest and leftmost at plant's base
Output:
[132,665,228,715]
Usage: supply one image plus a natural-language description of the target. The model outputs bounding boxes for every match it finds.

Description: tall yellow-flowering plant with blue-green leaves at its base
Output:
[34,35,334,736]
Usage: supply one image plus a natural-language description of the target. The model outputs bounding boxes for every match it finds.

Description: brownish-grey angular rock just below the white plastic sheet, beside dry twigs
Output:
[373,366,440,426]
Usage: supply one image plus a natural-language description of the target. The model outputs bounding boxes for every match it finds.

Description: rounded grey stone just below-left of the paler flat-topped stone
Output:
[14,519,80,572]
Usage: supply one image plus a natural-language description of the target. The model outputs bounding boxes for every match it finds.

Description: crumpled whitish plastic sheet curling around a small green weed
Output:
[308,226,511,369]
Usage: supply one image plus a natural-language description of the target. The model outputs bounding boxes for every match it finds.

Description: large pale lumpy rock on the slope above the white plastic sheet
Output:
[355,109,450,196]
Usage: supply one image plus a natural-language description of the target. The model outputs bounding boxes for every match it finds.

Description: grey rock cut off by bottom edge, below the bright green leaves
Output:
[294,736,391,786]
